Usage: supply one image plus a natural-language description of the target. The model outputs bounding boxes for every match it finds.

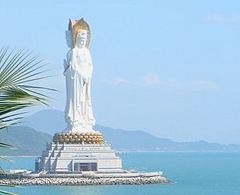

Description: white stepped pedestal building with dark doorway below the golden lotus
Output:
[35,143,122,173]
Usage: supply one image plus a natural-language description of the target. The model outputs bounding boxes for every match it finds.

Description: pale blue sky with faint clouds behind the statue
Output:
[0,0,240,144]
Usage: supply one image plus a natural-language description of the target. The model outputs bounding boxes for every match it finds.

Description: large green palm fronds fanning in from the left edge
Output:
[0,48,54,129]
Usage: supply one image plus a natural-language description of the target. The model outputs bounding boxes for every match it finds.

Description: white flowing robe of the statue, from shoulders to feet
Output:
[64,47,95,132]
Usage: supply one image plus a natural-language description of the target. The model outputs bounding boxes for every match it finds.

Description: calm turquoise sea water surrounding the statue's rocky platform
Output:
[0,152,240,195]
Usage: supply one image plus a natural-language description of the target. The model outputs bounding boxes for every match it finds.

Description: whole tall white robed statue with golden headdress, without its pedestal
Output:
[64,19,95,132]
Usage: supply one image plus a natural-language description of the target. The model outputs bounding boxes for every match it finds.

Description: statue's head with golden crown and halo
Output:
[68,18,90,48]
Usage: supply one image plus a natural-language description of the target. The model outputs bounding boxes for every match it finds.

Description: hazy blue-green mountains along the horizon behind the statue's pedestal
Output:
[0,110,240,155]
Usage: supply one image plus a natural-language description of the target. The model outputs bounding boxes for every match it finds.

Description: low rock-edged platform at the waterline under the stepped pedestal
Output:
[0,171,170,186]
